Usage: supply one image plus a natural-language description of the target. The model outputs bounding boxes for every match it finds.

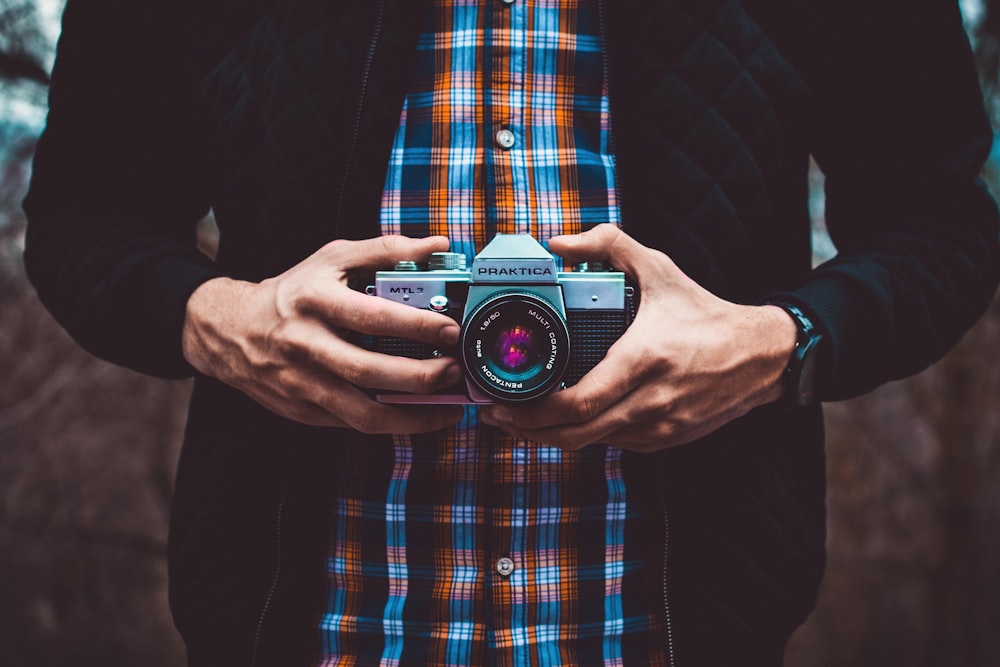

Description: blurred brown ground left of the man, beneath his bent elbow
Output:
[0,134,189,667]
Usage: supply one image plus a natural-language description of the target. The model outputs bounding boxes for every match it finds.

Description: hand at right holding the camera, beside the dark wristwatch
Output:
[481,225,796,452]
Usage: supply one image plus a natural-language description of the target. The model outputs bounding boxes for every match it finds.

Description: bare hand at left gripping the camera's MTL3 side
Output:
[183,236,462,434]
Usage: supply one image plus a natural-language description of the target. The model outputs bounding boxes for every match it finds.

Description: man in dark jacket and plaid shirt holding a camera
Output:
[26,0,1000,665]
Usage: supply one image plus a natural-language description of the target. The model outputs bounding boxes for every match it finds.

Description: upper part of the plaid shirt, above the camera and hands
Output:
[382,0,620,259]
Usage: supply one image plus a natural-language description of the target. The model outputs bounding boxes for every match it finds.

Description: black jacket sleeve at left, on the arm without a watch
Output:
[24,0,225,377]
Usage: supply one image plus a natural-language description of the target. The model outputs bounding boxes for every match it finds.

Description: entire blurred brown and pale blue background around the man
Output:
[0,0,1000,667]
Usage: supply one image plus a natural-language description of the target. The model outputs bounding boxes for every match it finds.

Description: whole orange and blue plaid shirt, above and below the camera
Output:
[317,0,664,667]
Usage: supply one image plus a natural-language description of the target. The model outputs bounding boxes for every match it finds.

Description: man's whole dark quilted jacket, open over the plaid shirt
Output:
[25,0,1000,665]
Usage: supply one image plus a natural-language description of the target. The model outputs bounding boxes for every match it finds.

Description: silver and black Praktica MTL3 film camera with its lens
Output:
[367,234,635,404]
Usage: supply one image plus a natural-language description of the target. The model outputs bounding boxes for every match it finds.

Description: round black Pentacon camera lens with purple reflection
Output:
[462,293,569,401]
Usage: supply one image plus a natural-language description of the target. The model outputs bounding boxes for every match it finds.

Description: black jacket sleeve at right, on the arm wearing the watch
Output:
[780,0,1000,400]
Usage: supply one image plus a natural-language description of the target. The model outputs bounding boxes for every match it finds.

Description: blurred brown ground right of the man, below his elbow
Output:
[786,301,1000,667]
